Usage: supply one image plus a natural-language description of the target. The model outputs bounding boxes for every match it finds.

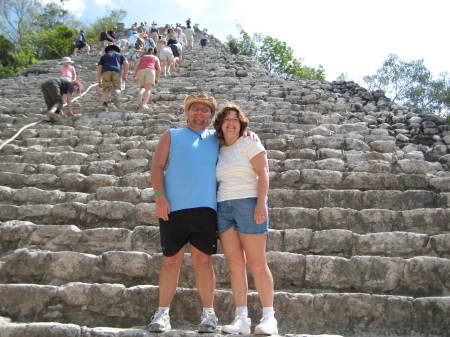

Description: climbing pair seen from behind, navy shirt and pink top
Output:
[97,45,161,111]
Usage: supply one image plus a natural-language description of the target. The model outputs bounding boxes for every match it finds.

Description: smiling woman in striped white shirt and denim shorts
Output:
[214,104,278,335]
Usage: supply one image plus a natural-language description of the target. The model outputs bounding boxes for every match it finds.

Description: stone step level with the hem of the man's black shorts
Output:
[0,221,450,259]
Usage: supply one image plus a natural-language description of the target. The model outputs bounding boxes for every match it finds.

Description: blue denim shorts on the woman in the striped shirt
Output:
[217,198,269,235]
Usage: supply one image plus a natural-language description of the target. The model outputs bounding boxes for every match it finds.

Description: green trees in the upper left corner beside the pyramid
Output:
[0,0,127,78]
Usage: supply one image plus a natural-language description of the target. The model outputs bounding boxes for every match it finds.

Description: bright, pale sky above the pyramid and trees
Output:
[58,0,450,84]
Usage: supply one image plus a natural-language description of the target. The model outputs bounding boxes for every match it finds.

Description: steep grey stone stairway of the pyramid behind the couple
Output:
[0,29,450,337]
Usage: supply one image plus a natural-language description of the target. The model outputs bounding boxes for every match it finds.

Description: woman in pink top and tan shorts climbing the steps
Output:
[133,47,161,108]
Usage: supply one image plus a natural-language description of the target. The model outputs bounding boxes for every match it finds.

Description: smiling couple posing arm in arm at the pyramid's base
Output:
[148,93,278,335]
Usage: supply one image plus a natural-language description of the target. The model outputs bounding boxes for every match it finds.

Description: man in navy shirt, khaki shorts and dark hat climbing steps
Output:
[97,45,128,111]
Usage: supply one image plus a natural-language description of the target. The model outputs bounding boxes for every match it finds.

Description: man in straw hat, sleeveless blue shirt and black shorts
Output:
[148,93,219,332]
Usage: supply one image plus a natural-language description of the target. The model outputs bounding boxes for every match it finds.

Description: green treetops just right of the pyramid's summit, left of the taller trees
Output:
[226,26,325,81]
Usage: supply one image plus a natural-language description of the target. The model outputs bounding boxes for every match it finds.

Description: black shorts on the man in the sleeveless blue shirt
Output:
[159,207,217,257]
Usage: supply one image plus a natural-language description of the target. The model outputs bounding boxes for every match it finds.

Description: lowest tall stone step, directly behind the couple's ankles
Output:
[0,283,450,336]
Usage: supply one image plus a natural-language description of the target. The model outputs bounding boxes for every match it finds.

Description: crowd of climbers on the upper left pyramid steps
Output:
[41,19,210,122]
